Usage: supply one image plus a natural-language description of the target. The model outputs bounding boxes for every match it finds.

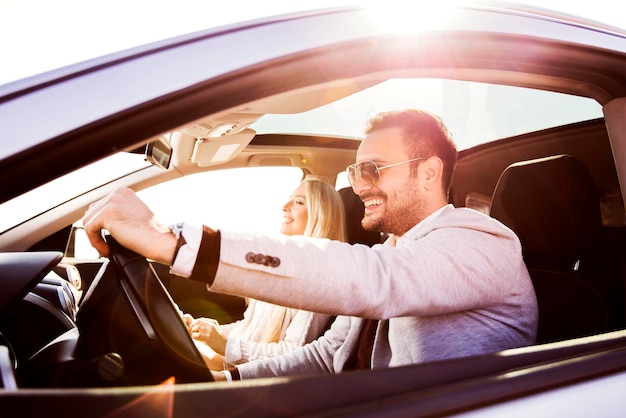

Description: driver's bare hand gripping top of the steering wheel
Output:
[83,188,176,265]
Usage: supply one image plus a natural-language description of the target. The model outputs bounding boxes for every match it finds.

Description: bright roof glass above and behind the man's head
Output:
[251,78,602,150]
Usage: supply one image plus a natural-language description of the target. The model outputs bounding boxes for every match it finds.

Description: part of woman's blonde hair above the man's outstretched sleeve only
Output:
[304,179,347,241]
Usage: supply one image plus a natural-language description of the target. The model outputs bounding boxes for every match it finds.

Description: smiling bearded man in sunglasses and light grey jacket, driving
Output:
[83,110,537,379]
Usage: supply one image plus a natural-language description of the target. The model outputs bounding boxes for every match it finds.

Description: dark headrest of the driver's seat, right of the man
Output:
[490,155,602,259]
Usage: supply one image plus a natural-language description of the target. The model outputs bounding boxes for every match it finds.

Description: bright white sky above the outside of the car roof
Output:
[0,0,626,85]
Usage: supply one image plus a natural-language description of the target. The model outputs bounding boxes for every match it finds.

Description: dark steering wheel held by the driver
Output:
[77,236,213,385]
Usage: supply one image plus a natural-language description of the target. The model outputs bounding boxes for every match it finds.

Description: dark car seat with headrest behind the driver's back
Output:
[490,155,621,343]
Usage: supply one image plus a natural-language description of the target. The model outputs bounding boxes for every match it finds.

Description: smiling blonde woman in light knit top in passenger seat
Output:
[185,179,346,370]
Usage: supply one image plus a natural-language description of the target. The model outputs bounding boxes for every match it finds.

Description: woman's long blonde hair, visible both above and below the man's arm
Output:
[259,179,347,343]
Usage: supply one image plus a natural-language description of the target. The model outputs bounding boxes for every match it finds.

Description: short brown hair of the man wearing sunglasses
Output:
[365,109,457,194]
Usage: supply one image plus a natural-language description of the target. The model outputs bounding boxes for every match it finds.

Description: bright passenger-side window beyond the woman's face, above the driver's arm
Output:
[138,167,303,237]
